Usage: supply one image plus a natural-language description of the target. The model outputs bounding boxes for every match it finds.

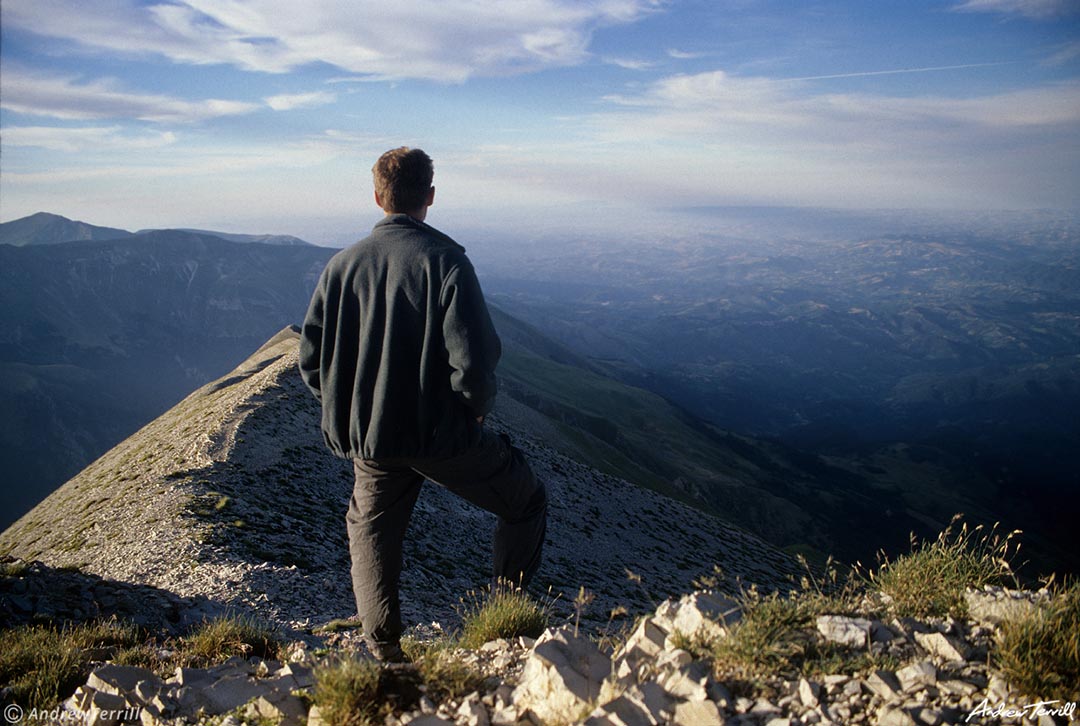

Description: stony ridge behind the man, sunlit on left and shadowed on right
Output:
[0,328,794,628]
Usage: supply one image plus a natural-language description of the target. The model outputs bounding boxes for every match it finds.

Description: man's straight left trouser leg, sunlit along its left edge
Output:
[346,460,423,659]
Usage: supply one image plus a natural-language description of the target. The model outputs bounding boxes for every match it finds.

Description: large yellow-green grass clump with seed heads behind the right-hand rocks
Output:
[867,514,1020,618]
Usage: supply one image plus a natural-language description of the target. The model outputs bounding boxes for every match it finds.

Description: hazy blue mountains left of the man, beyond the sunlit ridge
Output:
[0,214,335,526]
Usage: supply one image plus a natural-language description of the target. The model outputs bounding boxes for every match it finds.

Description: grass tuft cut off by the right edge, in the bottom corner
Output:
[994,581,1080,702]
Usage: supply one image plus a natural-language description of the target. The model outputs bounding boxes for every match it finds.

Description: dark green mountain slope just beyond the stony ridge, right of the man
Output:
[496,306,949,560]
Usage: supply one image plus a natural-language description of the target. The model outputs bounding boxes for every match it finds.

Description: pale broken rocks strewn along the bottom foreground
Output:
[52,590,1062,726]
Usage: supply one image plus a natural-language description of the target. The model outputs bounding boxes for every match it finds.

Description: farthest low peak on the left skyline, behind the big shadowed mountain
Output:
[0,212,311,247]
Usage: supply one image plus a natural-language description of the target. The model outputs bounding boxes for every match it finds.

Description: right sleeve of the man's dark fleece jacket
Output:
[441,259,502,416]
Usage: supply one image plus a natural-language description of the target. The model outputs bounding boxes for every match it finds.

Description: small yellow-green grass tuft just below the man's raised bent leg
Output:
[458,587,551,648]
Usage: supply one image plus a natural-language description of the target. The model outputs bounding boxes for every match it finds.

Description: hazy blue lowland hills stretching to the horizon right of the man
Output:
[484,218,1080,572]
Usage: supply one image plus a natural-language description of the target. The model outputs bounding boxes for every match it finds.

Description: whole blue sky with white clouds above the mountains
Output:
[0,0,1080,243]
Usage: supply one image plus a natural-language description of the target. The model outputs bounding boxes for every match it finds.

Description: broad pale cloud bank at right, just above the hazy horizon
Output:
[579,70,1080,206]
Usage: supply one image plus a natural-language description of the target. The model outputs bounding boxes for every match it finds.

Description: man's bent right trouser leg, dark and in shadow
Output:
[414,430,548,587]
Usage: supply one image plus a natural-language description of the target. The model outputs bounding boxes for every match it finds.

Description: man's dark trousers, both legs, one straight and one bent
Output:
[346,429,548,658]
